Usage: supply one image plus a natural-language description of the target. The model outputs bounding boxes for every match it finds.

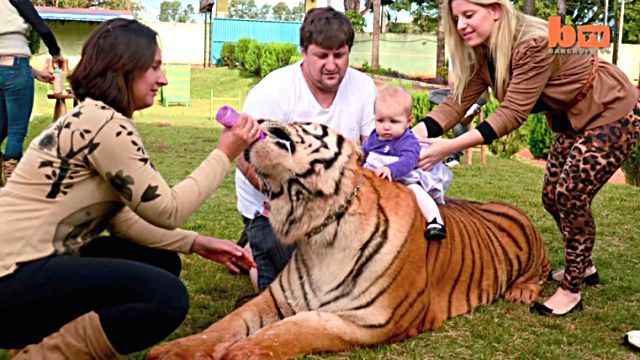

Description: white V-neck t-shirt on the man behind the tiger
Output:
[236,61,376,219]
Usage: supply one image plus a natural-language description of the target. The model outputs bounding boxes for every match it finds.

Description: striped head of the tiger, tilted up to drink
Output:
[245,120,363,242]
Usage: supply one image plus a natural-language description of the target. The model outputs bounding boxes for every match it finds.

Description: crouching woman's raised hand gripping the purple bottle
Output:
[218,113,260,161]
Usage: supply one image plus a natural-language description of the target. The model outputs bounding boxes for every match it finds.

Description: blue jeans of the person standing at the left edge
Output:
[0,58,33,159]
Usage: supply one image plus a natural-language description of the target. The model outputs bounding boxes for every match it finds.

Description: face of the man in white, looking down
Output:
[302,44,349,92]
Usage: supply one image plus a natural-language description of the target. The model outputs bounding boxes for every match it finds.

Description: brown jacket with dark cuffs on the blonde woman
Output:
[428,37,636,137]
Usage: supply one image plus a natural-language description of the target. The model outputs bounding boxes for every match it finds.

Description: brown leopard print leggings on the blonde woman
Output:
[542,113,640,293]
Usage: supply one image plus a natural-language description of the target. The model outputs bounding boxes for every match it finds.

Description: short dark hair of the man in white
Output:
[300,6,355,50]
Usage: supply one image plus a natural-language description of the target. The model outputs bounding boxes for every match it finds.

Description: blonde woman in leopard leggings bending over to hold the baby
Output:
[414,0,640,316]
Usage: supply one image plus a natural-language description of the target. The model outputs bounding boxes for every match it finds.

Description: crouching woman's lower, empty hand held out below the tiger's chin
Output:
[191,235,256,274]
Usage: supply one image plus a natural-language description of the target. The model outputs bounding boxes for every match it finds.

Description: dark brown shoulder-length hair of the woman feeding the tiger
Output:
[69,19,158,117]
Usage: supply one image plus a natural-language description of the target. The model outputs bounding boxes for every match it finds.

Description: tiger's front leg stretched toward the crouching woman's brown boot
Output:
[147,291,279,360]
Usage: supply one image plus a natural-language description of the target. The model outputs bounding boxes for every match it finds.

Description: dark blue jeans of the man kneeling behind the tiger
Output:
[242,215,296,291]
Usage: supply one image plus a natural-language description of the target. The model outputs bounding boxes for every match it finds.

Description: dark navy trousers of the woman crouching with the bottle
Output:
[0,238,189,354]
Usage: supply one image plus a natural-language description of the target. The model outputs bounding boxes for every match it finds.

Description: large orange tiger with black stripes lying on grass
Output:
[148,120,549,359]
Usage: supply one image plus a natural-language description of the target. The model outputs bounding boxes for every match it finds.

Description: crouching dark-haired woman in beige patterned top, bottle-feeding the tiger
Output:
[0,19,259,359]
